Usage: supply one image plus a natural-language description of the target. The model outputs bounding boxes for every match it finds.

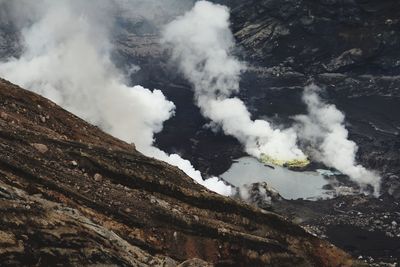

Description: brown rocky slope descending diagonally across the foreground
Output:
[0,80,354,266]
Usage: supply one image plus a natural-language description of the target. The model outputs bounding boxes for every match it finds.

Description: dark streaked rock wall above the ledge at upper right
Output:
[228,0,400,75]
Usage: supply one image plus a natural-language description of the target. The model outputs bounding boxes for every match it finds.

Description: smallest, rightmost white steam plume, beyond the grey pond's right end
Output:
[295,85,380,194]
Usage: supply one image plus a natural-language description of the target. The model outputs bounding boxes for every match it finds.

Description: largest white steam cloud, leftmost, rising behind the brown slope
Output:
[0,0,231,195]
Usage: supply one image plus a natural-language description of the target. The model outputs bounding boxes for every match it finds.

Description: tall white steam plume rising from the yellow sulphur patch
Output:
[163,1,306,162]
